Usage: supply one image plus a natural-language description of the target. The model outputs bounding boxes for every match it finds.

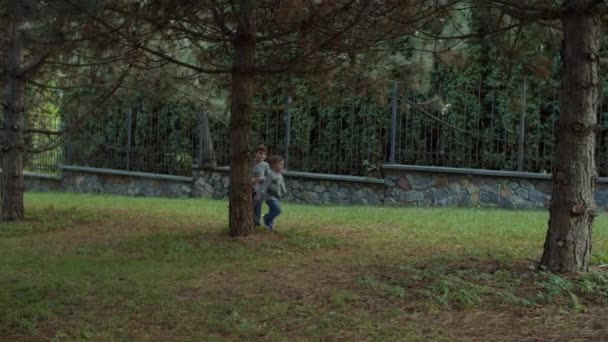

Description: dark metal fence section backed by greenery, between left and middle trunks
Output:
[66,107,198,175]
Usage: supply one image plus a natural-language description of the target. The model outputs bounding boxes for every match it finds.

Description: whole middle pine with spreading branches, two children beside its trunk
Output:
[92,0,437,236]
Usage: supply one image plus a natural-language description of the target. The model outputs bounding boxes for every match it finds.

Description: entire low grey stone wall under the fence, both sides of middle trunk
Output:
[26,165,608,210]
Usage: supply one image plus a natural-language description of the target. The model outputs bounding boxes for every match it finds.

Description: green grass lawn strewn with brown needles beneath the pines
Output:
[0,193,608,341]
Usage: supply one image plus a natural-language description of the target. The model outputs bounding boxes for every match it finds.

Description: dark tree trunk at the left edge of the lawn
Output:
[0,0,25,221]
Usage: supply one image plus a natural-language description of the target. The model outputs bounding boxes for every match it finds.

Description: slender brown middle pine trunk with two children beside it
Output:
[229,0,256,236]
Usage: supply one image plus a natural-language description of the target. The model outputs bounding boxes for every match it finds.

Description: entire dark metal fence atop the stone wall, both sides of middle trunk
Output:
[13,82,608,177]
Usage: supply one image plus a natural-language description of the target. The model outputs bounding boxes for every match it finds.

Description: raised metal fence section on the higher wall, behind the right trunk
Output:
[388,81,608,176]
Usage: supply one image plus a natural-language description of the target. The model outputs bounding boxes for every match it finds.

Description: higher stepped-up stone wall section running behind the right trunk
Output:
[383,165,608,210]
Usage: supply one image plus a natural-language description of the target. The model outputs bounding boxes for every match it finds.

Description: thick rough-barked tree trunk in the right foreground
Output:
[540,0,601,272]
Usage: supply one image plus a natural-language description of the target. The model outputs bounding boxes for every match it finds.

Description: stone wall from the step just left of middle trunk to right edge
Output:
[192,165,608,210]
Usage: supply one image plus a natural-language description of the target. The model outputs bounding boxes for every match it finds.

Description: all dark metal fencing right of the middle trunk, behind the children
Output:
[240,81,608,177]
